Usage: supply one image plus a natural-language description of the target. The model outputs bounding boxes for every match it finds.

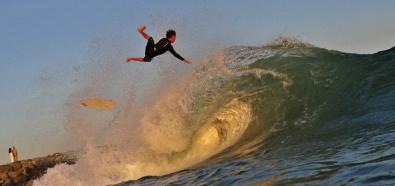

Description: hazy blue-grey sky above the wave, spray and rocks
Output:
[0,0,395,164]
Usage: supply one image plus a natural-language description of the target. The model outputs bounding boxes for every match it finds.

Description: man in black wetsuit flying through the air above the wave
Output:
[126,26,191,64]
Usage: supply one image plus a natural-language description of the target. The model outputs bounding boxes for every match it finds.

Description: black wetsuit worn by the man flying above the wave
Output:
[144,37,184,62]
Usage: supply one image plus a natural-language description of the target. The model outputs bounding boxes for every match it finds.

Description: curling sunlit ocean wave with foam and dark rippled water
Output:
[36,38,395,185]
